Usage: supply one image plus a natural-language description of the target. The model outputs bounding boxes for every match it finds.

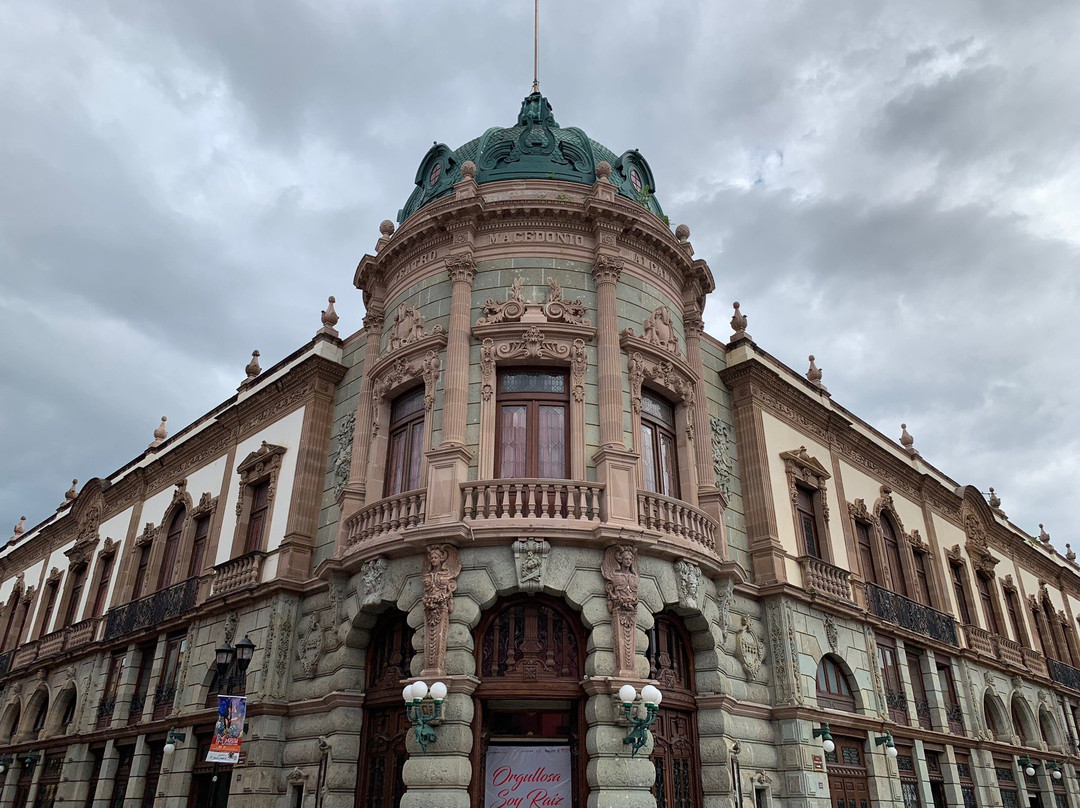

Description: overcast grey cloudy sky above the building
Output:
[0,0,1080,548]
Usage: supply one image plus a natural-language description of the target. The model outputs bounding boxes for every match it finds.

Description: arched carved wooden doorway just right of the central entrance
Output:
[646,612,702,808]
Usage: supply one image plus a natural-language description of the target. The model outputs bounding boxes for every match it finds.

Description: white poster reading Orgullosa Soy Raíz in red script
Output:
[484,746,571,808]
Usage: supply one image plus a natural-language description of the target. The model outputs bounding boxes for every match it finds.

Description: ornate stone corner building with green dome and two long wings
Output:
[0,93,1080,808]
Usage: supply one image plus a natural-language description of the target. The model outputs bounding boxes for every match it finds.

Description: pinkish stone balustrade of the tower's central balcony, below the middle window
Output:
[461,477,604,524]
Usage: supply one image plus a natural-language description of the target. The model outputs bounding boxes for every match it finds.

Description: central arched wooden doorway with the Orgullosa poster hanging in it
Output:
[470,595,588,808]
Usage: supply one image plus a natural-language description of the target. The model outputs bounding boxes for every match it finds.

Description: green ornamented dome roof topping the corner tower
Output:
[397,93,663,223]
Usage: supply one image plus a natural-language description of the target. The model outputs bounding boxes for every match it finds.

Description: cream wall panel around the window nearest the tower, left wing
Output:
[212,407,306,564]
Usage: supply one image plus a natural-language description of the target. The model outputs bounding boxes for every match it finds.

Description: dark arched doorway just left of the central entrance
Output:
[356,611,414,808]
